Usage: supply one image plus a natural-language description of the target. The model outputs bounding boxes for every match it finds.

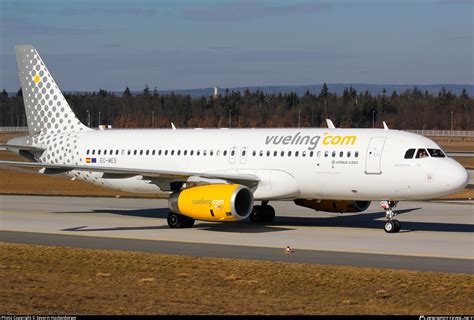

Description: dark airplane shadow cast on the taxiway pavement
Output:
[57,208,474,233]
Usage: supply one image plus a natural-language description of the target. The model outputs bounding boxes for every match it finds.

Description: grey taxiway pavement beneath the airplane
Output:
[0,195,474,274]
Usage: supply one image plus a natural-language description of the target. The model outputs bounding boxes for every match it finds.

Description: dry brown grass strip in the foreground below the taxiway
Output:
[0,243,474,315]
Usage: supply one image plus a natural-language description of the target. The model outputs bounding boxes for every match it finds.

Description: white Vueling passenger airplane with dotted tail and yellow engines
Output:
[0,45,468,233]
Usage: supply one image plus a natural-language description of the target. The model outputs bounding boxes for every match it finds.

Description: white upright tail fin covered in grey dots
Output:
[15,46,90,134]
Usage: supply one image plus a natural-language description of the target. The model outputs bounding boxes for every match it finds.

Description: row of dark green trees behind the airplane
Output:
[0,85,474,130]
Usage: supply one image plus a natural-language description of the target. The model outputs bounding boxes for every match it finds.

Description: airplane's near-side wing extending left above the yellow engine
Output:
[0,161,260,188]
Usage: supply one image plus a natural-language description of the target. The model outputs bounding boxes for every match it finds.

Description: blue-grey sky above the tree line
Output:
[0,0,474,91]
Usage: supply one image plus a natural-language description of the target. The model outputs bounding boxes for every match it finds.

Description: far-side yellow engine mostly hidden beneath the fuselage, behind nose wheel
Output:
[295,199,370,213]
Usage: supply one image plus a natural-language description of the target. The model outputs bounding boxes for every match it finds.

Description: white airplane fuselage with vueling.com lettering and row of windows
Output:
[31,129,467,200]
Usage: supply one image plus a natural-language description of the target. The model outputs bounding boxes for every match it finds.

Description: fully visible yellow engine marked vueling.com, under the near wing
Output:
[168,184,253,221]
